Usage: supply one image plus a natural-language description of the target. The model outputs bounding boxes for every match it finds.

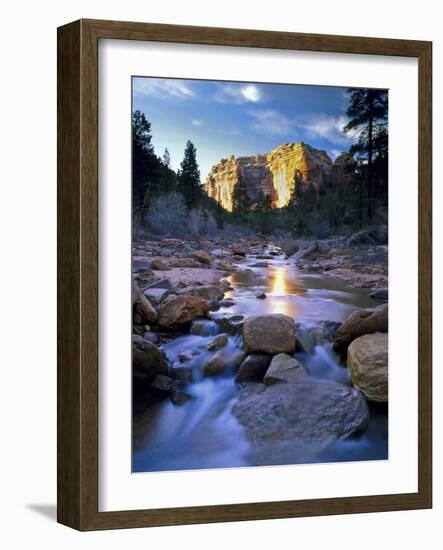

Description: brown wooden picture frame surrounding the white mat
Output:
[57,20,432,531]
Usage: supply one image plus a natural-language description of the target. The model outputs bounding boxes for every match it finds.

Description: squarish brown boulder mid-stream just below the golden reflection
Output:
[243,313,295,355]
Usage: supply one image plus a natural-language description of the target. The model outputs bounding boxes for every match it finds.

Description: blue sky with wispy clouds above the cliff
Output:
[133,77,356,182]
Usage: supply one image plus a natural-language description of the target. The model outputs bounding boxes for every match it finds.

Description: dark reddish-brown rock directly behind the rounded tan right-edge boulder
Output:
[333,304,388,355]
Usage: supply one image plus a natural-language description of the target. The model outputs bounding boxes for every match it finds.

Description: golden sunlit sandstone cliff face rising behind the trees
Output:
[205,142,340,211]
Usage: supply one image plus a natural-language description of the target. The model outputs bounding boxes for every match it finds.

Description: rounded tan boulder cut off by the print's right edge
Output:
[347,332,388,403]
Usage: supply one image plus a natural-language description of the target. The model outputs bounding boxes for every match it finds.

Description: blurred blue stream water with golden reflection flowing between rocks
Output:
[133,252,388,472]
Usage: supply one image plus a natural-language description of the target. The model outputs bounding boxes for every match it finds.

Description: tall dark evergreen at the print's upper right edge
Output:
[343,88,388,221]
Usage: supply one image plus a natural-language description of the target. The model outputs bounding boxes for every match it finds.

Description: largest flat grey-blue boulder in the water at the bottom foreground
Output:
[232,377,369,452]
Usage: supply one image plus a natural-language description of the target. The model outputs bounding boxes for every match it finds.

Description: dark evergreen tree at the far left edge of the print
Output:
[132,111,160,223]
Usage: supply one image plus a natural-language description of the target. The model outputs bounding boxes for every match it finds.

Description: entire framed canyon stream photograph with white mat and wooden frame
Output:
[58,20,432,530]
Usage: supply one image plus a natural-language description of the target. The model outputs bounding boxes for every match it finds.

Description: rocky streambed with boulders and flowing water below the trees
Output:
[133,238,388,472]
